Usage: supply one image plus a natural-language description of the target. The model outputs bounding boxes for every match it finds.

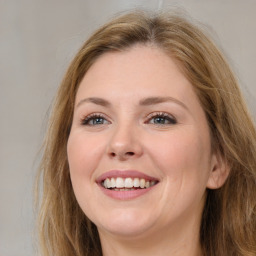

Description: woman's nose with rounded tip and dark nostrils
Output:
[107,122,143,161]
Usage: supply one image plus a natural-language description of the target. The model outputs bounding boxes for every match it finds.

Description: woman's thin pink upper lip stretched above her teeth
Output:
[96,170,158,183]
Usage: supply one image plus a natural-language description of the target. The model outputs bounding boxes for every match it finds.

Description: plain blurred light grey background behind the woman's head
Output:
[0,0,256,256]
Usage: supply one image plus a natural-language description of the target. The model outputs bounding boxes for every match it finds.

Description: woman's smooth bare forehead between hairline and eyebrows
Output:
[76,45,197,106]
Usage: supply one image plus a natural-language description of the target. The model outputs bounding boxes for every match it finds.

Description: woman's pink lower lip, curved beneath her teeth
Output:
[98,184,156,200]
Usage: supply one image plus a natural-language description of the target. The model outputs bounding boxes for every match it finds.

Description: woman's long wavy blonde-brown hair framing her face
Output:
[37,11,256,256]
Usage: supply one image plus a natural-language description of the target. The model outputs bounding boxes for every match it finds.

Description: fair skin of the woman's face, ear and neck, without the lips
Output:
[67,45,226,256]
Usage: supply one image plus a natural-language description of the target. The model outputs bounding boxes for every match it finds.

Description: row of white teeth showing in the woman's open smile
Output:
[102,177,156,191]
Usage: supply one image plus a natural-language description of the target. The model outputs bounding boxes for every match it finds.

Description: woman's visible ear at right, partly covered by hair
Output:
[207,153,230,189]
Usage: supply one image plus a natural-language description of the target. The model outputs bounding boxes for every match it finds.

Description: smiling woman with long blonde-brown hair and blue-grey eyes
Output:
[36,12,256,256]
